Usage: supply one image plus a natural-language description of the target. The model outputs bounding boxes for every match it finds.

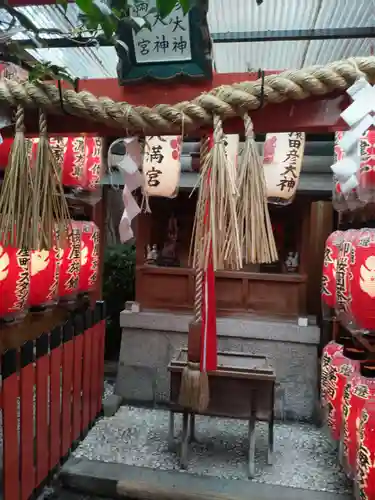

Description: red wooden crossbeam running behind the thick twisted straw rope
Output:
[3,73,349,136]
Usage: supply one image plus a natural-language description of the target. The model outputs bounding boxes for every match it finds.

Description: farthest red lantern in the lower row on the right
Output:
[326,344,367,440]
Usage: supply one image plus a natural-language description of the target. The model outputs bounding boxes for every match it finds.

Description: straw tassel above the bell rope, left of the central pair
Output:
[193,116,242,271]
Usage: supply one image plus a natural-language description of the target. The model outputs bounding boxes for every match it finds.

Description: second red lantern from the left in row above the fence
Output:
[29,247,60,307]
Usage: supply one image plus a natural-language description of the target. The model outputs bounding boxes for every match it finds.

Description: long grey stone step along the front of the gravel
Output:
[60,458,352,500]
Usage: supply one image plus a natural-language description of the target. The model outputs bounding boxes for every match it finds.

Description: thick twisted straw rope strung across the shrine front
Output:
[0,56,375,135]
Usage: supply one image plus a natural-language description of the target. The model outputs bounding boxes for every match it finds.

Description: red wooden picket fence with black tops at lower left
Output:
[1,301,105,500]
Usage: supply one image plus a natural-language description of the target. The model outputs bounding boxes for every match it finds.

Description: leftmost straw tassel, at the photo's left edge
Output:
[0,106,33,248]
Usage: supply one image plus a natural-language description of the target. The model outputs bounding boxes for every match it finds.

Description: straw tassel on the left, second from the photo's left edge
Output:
[32,111,70,250]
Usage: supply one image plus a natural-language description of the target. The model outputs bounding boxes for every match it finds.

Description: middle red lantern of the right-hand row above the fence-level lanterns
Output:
[335,229,358,326]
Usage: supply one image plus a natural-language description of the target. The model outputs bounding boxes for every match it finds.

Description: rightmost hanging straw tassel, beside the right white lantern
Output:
[238,114,278,264]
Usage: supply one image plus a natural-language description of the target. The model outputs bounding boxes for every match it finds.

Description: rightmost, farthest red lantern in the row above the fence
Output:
[77,222,99,292]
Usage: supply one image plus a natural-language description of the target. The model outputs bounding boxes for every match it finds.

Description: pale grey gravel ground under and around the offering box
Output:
[74,406,351,493]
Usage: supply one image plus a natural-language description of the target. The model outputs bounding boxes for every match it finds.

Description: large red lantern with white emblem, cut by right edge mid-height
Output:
[350,229,375,330]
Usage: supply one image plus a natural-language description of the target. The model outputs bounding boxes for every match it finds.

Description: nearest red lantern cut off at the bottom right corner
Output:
[355,398,375,500]
